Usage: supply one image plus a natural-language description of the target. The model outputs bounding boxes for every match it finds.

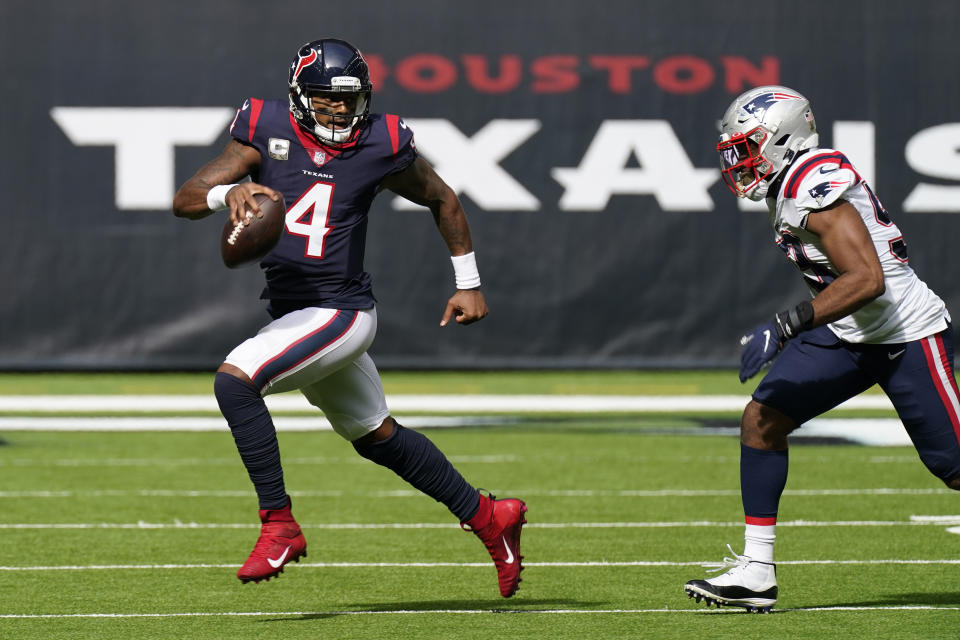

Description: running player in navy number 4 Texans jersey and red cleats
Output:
[173,38,526,597]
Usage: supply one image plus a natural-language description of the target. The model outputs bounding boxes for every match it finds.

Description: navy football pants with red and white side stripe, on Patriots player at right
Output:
[753,326,960,480]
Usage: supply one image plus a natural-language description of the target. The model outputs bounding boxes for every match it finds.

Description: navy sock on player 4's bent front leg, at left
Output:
[213,372,287,509]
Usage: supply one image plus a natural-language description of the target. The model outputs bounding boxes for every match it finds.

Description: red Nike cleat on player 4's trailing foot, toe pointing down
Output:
[460,493,527,598]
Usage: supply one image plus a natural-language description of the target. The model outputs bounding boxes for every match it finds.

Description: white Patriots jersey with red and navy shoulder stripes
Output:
[767,149,949,344]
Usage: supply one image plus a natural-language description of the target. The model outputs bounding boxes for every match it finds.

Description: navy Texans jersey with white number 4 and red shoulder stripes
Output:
[230,98,417,310]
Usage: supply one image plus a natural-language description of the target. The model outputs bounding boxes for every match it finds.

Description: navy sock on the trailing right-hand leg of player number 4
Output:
[353,421,480,522]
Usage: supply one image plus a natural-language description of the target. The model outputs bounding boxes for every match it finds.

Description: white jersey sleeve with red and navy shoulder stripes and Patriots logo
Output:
[786,152,862,227]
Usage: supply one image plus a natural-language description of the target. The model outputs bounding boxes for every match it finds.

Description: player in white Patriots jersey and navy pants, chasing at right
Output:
[684,86,960,612]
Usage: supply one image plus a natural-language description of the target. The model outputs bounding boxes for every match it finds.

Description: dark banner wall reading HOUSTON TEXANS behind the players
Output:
[0,0,960,369]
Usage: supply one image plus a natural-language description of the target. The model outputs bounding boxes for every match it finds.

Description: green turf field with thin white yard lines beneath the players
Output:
[0,372,960,639]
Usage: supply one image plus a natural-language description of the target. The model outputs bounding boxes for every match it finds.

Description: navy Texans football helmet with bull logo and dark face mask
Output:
[288,38,373,146]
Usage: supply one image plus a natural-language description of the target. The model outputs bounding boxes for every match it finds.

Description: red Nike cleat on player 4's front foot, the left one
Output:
[237,503,307,584]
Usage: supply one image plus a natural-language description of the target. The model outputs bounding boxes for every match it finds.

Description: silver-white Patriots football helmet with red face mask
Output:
[717,85,820,200]
